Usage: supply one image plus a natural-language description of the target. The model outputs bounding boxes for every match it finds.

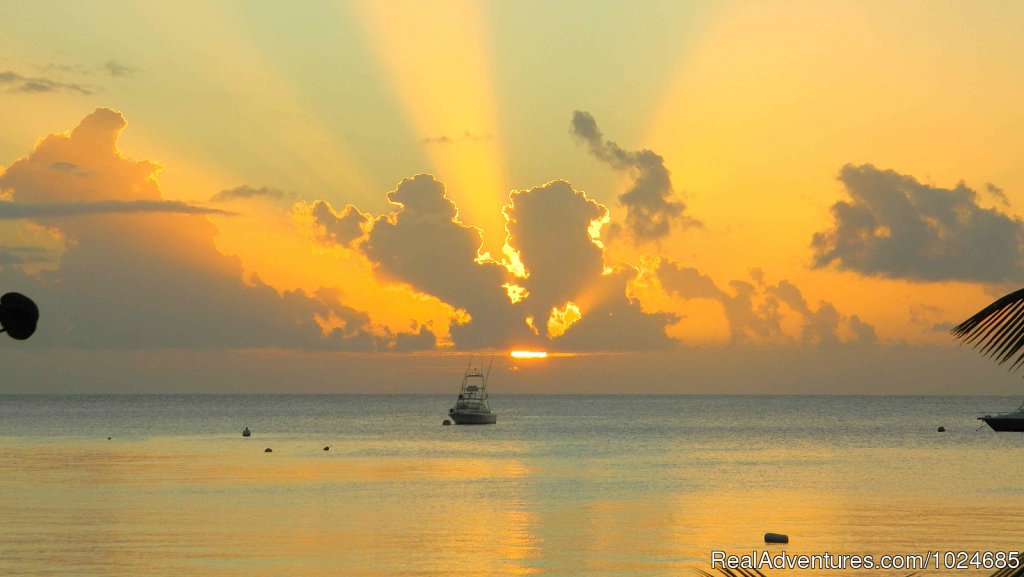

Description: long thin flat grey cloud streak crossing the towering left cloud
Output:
[0,200,233,219]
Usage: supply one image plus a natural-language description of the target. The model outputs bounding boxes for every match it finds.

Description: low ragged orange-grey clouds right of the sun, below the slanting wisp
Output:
[656,259,878,345]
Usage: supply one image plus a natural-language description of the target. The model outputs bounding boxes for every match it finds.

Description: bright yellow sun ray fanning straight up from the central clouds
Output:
[355,0,510,254]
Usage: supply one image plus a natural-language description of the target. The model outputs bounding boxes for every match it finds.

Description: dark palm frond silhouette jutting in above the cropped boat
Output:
[949,289,1024,370]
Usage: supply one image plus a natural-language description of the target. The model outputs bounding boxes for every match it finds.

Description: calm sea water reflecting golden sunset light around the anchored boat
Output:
[0,395,1024,577]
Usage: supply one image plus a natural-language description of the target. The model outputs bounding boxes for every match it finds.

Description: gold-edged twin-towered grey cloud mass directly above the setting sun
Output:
[307,174,677,351]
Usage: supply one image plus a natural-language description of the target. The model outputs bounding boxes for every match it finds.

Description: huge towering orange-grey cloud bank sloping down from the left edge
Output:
[0,109,384,351]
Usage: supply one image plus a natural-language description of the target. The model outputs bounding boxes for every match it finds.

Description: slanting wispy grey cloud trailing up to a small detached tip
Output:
[571,111,699,242]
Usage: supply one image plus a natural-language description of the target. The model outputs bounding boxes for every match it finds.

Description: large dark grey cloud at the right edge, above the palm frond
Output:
[811,164,1024,283]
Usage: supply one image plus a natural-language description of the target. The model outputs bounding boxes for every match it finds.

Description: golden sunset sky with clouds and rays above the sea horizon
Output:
[0,0,1024,395]
